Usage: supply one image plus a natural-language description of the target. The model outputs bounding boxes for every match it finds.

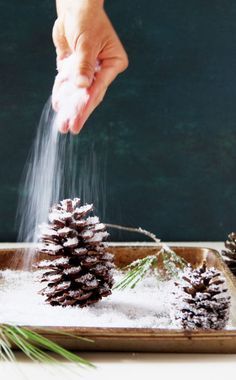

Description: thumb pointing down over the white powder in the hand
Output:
[75,38,97,88]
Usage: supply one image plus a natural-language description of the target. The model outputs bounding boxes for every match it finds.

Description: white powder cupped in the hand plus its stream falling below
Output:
[17,54,89,269]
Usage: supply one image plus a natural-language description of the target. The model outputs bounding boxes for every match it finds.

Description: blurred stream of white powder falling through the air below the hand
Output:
[17,99,77,268]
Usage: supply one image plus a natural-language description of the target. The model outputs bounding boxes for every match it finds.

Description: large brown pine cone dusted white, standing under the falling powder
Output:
[37,198,114,307]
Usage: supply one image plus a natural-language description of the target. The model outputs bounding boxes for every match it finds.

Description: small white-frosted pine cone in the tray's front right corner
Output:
[174,262,230,329]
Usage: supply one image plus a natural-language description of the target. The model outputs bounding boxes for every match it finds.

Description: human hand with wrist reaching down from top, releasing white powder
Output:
[52,0,128,133]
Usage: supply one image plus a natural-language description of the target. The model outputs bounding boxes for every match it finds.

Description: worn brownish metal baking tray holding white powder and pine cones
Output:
[0,243,236,353]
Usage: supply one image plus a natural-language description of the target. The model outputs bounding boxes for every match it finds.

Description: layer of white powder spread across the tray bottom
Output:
[0,270,176,329]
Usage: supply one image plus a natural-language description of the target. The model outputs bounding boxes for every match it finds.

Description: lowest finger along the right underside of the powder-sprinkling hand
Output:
[69,59,120,134]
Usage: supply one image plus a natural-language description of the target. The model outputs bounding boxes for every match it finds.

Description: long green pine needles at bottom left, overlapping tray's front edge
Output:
[0,324,94,367]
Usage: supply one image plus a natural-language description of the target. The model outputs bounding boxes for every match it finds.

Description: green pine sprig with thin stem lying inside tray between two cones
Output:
[106,224,187,290]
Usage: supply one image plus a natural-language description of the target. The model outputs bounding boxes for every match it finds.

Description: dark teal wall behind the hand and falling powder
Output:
[0,0,236,241]
